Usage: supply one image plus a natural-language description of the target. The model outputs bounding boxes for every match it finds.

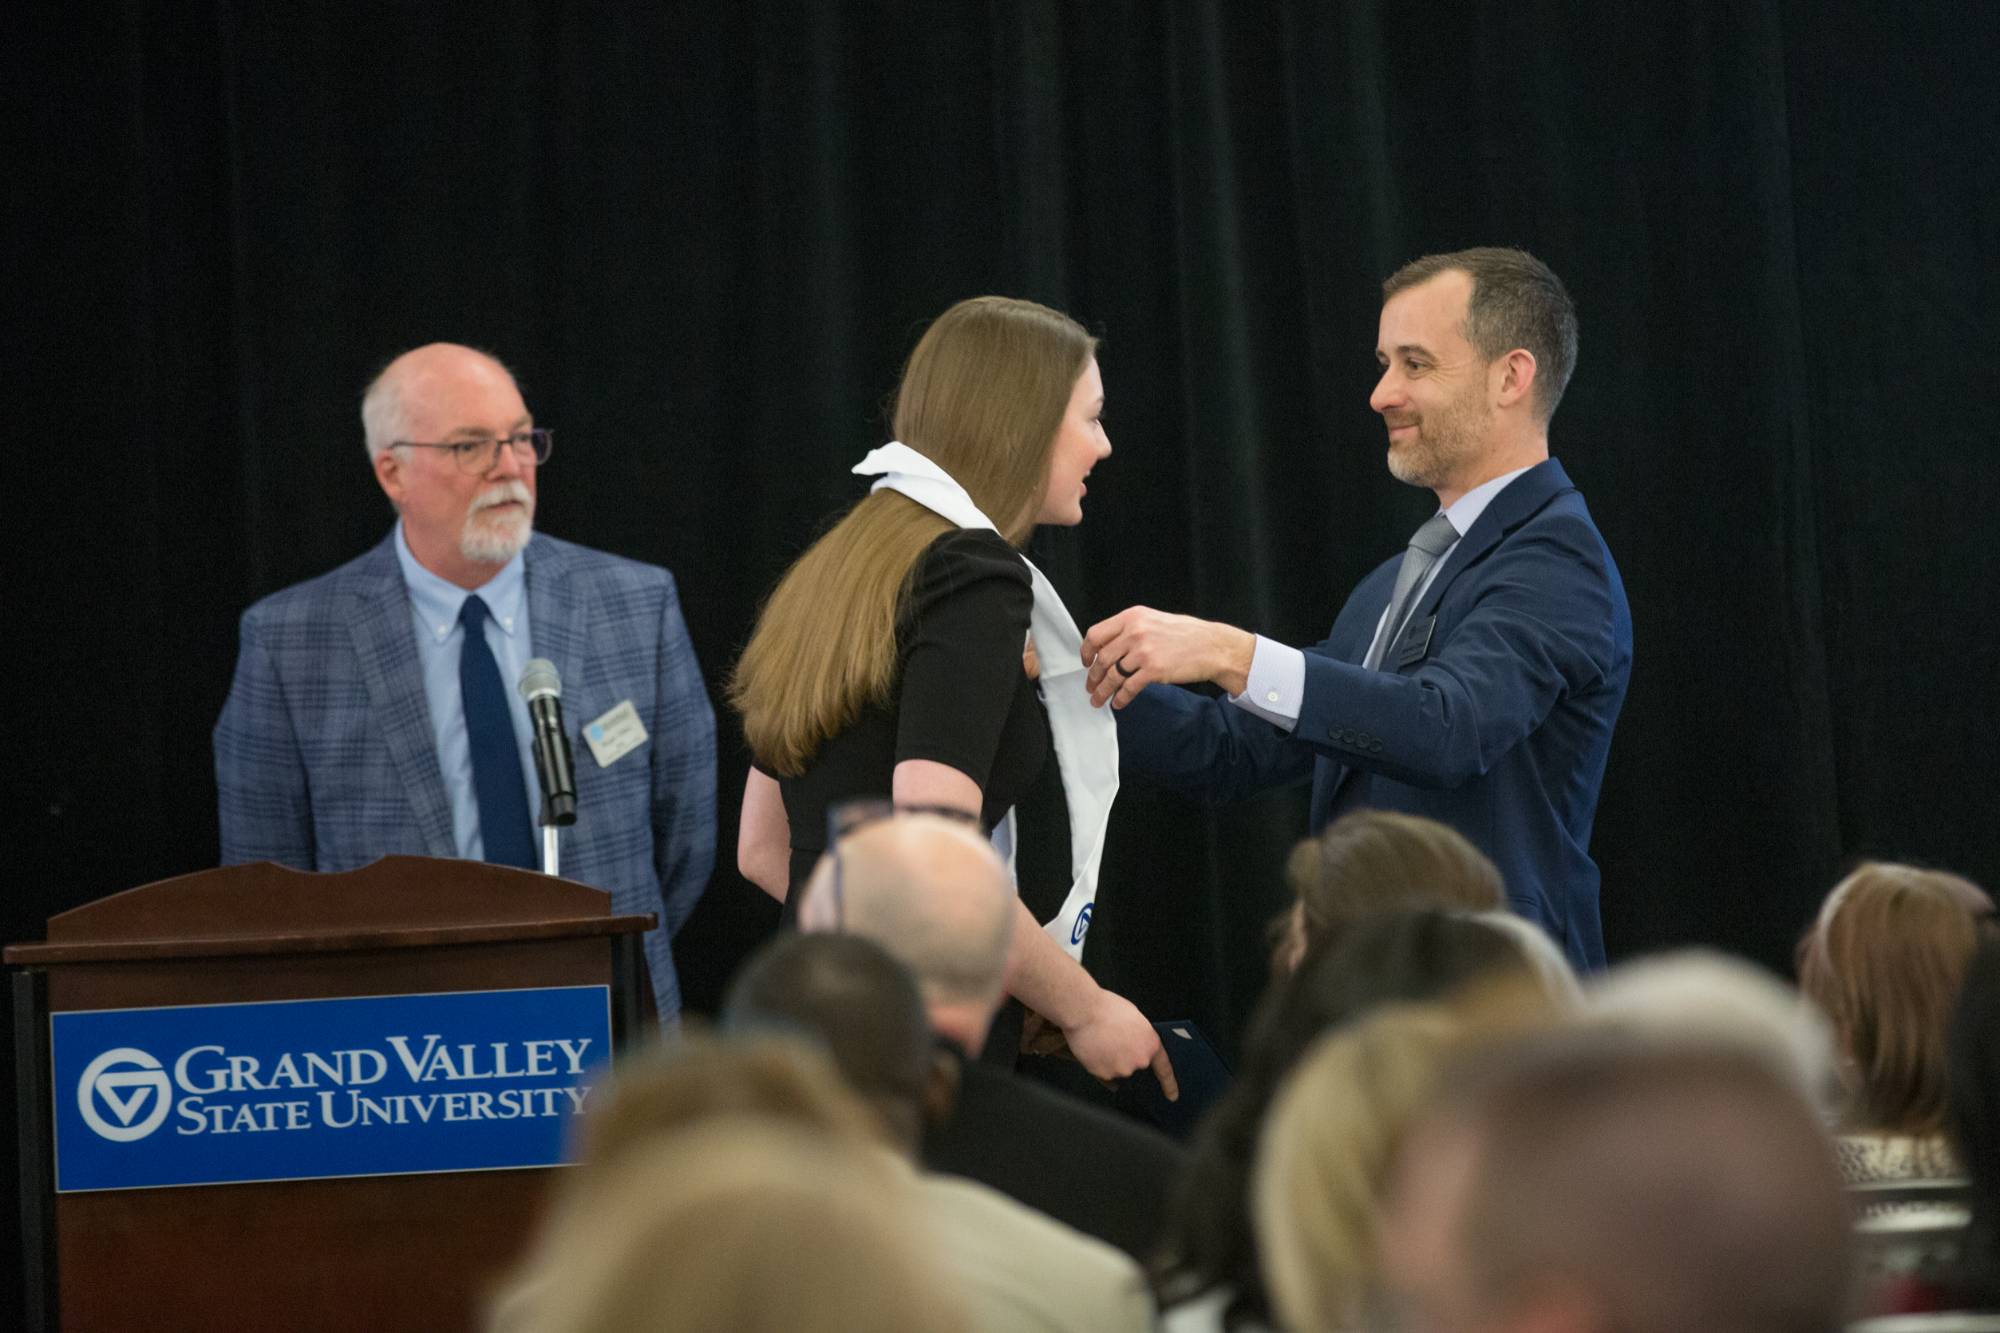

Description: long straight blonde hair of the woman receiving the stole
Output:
[730,296,1096,777]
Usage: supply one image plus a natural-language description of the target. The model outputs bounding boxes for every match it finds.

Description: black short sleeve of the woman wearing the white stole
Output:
[896,528,1034,791]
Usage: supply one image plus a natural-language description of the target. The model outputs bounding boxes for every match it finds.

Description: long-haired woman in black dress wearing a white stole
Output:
[730,296,1172,1089]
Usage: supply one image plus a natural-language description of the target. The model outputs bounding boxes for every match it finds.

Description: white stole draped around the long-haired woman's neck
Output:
[854,442,1118,961]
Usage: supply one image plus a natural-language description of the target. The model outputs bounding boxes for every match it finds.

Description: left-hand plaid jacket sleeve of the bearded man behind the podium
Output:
[214,608,316,871]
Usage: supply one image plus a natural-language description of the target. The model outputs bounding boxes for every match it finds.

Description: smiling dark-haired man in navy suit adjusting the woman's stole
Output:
[1084,248,1632,969]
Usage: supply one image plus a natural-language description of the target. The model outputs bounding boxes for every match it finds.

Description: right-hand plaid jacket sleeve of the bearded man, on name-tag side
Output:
[646,574,716,935]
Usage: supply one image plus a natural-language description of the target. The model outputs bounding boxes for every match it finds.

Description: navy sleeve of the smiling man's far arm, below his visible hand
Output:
[1118,676,1312,801]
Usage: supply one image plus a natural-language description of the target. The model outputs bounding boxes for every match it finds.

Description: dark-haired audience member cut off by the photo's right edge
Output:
[1946,939,2000,1309]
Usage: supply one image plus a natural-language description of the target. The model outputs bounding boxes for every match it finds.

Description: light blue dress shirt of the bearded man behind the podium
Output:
[396,520,542,861]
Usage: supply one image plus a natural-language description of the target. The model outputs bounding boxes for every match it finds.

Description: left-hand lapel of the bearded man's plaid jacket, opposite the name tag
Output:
[346,532,458,857]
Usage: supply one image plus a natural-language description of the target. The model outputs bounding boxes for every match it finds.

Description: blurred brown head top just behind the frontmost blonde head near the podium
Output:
[576,1020,884,1171]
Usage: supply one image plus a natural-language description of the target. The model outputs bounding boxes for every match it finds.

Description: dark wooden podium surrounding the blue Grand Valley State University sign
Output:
[4,857,652,1331]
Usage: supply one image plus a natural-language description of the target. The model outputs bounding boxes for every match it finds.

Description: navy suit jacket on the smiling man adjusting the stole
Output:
[1118,458,1632,969]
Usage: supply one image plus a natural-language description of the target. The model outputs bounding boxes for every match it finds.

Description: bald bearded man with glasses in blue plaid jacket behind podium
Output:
[214,344,716,1023]
